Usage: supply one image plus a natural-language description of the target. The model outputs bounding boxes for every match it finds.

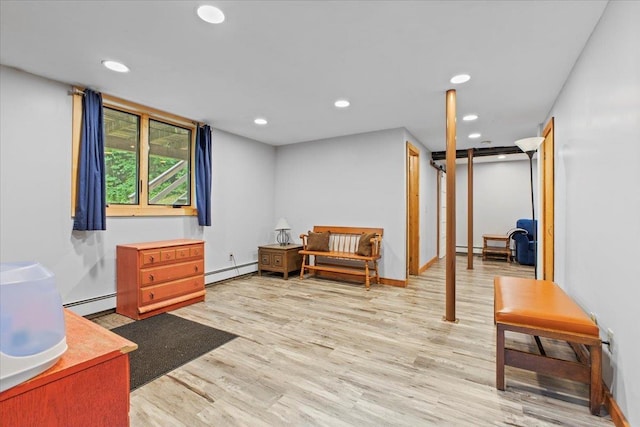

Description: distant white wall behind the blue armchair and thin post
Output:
[456,156,540,252]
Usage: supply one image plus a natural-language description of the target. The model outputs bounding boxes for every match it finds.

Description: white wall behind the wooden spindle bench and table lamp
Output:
[275,129,406,280]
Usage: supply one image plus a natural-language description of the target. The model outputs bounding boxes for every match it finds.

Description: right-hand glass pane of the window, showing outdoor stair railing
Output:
[149,120,191,206]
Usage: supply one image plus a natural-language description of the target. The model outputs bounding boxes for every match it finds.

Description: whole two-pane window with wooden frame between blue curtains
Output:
[72,90,197,216]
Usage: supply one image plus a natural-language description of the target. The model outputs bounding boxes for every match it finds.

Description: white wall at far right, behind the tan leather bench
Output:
[551,1,640,426]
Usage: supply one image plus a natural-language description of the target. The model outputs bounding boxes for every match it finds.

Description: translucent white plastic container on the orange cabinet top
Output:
[0,262,67,392]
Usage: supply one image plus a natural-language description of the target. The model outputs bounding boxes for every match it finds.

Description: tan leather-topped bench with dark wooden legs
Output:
[493,276,603,415]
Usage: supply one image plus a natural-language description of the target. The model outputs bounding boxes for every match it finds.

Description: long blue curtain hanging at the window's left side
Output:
[73,89,107,230]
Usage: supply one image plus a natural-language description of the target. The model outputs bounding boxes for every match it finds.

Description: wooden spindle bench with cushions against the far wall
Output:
[300,225,383,290]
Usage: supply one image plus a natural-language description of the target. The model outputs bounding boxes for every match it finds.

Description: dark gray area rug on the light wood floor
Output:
[111,313,237,391]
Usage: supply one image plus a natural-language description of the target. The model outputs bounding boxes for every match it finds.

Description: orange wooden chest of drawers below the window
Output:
[116,240,205,320]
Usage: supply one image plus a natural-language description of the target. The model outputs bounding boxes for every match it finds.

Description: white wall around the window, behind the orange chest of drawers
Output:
[0,67,275,314]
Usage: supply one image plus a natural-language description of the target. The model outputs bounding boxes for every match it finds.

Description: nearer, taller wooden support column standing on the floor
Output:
[444,89,456,322]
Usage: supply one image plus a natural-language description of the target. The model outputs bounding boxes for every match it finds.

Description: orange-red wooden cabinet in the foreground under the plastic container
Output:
[0,310,138,427]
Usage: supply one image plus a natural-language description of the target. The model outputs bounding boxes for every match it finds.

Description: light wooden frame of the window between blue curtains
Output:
[71,87,198,217]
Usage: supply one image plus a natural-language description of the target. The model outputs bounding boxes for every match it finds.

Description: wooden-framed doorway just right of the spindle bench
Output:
[407,141,420,278]
